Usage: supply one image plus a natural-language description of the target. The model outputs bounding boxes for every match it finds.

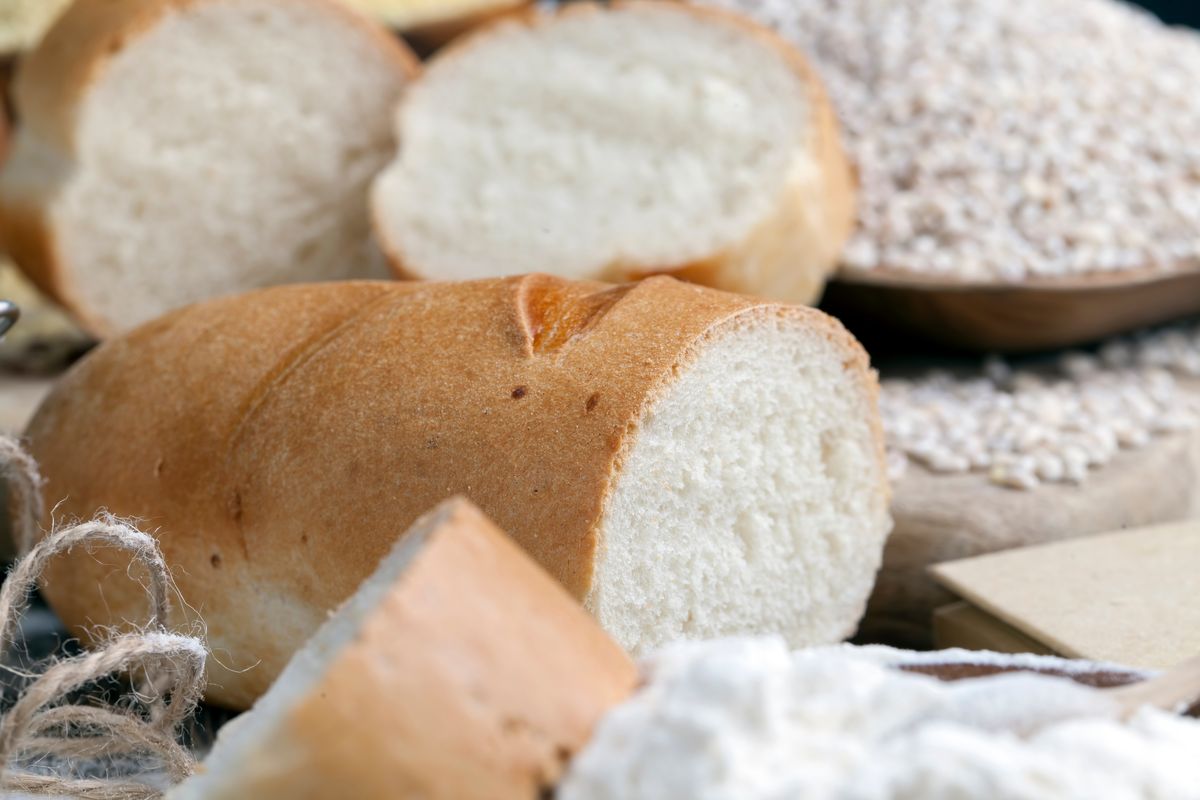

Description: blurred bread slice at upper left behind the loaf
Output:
[0,0,415,335]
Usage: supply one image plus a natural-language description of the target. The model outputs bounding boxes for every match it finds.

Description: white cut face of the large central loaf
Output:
[588,313,890,654]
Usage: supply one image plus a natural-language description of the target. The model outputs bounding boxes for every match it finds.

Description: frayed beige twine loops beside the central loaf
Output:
[0,437,206,800]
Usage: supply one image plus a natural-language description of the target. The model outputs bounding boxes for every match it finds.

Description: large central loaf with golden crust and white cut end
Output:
[28,276,890,705]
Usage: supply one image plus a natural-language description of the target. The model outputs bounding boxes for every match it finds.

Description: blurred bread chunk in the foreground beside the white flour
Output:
[168,500,637,800]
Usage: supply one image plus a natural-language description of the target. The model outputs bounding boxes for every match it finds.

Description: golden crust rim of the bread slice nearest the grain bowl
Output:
[372,0,857,303]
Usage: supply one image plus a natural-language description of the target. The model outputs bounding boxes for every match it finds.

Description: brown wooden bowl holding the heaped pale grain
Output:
[822,263,1200,353]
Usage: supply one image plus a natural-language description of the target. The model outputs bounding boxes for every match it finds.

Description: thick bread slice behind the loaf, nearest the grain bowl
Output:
[372,2,853,302]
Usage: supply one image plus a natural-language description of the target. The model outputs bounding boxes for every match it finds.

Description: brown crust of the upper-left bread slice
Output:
[0,0,419,337]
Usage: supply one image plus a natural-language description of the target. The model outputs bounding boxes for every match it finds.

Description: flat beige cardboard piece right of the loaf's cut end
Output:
[930,519,1200,669]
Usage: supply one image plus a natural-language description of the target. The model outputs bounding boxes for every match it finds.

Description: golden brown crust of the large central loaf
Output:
[29,275,882,705]
